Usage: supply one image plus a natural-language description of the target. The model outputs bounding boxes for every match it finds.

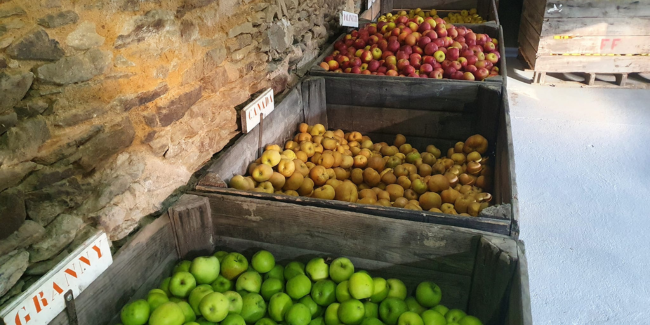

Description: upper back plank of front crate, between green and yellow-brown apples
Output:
[200,190,506,275]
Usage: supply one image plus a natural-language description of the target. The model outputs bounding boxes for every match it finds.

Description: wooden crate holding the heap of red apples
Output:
[309,22,508,84]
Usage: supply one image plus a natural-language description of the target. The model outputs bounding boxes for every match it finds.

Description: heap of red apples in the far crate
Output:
[320,16,501,80]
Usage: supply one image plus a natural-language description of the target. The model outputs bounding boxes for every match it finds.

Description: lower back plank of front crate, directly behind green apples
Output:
[216,237,471,309]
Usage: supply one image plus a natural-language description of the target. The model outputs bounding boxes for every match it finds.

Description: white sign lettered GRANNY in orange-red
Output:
[0,232,113,325]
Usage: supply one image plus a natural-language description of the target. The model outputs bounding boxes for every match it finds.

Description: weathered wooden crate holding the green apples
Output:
[51,193,532,325]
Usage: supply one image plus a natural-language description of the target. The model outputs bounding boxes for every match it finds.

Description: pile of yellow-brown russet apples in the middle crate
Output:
[229,123,492,217]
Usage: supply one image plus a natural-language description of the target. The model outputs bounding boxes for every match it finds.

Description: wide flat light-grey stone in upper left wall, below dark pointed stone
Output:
[36,49,113,85]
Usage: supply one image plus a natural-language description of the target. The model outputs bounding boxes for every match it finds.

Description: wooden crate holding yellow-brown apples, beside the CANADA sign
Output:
[196,76,519,238]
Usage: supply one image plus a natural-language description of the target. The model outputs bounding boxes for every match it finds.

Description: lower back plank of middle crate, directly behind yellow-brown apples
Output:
[327,104,476,139]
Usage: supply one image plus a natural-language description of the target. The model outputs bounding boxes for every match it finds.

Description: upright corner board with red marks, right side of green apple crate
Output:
[467,238,517,325]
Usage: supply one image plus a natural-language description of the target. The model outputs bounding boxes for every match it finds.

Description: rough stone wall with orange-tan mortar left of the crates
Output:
[0,0,359,305]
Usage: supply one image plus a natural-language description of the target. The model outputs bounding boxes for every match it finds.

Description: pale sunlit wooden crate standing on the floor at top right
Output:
[519,0,650,83]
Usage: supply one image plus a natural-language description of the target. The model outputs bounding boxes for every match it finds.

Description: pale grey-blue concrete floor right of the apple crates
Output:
[508,58,650,325]
